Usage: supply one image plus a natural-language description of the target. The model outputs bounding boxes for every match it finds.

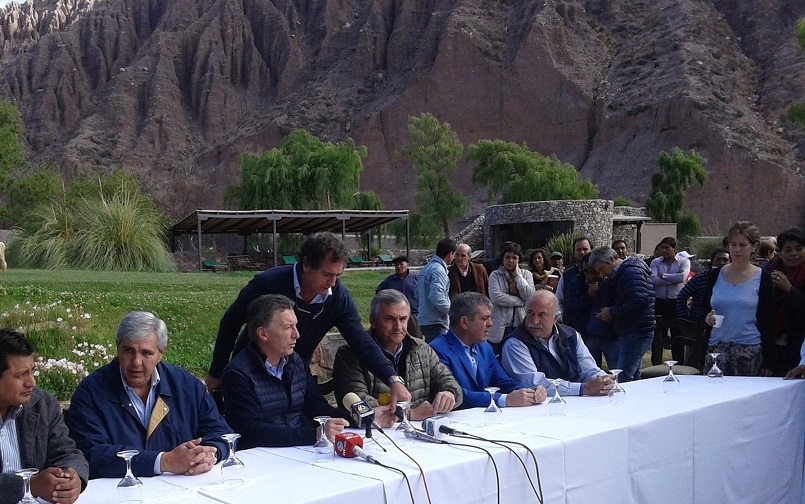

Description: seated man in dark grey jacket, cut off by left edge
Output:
[0,329,89,504]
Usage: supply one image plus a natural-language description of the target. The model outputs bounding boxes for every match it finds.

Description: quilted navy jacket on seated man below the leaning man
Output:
[221,343,346,449]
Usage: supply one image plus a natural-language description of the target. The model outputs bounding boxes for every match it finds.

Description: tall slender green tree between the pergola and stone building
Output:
[400,113,468,237]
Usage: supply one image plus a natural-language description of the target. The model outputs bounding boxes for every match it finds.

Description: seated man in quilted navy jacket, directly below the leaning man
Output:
[221,294,394,448]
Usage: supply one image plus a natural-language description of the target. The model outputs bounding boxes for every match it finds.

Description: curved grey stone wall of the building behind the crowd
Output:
[484,200,620,255]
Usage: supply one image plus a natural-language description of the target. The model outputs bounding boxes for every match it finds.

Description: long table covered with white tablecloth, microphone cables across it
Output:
[78,376,805,504]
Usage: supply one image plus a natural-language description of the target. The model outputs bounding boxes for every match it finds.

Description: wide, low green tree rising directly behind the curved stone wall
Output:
[467,140,598,203]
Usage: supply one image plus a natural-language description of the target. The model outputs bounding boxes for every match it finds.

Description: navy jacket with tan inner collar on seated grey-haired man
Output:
[67,358,232,478]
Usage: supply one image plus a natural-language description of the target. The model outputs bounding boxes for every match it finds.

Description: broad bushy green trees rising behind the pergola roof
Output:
[224,129,366,210]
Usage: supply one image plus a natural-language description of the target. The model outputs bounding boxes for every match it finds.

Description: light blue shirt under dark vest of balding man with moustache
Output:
[501,325,606,395]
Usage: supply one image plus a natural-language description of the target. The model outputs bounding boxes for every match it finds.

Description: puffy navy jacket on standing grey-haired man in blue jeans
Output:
[609,257,657,335]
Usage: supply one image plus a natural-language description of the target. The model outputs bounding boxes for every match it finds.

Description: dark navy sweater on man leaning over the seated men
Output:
[209,264,395,380]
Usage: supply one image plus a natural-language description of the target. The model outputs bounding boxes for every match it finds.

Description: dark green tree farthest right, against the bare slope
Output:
[646,147,707,237]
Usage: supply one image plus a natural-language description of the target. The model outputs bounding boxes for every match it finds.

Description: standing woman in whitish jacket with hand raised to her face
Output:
[487,243,534,353]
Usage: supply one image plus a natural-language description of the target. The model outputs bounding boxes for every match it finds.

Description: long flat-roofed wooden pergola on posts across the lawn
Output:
[171,208,411,271]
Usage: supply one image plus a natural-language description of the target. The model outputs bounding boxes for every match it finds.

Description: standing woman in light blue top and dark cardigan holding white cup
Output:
[702,221,774,376]
